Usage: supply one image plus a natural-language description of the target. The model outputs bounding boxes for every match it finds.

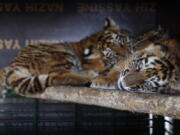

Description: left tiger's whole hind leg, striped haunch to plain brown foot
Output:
[6,69,95,95]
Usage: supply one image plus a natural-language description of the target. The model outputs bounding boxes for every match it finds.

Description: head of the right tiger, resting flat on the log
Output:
[118,43,180,93]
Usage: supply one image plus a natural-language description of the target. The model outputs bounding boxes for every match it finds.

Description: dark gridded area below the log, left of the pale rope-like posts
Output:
[0,96,149,135]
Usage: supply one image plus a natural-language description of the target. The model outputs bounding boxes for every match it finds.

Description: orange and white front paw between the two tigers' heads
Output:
[90,77,116,89]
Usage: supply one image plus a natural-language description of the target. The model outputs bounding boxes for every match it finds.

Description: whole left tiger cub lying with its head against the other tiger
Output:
[3,18,129,94]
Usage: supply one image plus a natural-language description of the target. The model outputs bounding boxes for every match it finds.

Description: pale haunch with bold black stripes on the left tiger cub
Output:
[5,69,48,94]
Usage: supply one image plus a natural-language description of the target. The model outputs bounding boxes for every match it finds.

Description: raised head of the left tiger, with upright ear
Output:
[81,18,130,72]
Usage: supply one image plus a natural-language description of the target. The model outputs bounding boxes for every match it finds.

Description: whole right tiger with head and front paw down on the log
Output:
[91,35,180,94]
